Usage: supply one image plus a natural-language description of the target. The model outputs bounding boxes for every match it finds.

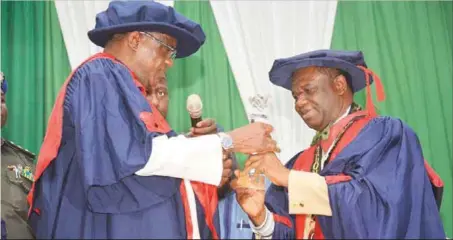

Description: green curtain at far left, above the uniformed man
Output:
[1,1,70,154]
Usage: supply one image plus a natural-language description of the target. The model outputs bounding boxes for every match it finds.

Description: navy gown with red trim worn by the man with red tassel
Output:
[266,112,445,239]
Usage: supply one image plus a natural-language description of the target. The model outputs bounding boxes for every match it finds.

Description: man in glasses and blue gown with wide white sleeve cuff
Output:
[28,1,276,239]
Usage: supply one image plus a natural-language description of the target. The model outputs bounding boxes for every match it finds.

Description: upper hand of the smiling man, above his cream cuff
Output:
[244,152,290,187]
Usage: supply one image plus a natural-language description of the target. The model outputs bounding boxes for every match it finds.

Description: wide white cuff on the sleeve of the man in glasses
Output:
[135,135,223,186]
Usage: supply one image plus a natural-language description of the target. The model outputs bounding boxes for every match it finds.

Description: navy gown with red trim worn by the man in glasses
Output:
[28,54,219,239]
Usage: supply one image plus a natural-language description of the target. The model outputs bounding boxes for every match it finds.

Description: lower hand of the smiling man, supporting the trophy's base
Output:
[231,170,266,226]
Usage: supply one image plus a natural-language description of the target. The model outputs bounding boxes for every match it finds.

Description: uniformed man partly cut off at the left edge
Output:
[0,72,35,239]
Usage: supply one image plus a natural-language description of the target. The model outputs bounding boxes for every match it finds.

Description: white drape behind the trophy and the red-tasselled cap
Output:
[211,0,337,163]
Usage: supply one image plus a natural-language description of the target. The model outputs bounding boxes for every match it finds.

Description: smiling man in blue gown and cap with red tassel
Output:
[233,50,445,239]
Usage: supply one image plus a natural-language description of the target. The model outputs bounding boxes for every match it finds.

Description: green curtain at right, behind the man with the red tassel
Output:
[332,1,453,237]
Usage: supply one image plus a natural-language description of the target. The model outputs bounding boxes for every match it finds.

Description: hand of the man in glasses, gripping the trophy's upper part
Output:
[228,122,280,154]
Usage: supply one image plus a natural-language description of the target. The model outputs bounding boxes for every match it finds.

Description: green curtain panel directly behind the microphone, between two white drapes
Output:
[168,1,248,164]
